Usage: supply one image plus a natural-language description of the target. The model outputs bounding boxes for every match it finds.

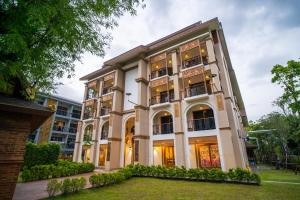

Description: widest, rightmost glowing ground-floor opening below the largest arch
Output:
[189,136,221,168]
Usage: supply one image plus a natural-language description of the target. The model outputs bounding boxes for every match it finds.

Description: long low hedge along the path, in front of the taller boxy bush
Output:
[21,160,95,182]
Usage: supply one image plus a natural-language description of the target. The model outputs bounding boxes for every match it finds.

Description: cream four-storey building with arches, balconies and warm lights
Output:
[73,18,248,170]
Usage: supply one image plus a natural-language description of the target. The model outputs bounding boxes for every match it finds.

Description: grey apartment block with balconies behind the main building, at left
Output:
[28,94,82,156]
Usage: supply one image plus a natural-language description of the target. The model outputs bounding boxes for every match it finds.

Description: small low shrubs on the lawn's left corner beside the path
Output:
[47,177,86,198]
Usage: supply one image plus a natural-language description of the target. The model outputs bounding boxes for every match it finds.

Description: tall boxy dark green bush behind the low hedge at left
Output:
[24,142,60,168]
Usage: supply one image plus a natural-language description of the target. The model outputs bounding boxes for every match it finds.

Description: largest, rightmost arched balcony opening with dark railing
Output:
[187,105,216,131]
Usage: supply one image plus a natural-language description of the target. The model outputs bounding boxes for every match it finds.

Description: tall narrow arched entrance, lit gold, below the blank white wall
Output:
[124,117,135,166]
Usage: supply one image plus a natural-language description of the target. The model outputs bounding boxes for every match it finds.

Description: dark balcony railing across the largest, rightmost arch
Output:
[188,117,216,131]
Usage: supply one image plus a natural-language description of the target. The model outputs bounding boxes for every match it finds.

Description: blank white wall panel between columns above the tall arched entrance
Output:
[124,67,138,110]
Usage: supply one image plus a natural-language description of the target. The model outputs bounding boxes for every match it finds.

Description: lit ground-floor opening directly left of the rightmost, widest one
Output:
[153,140,175,167]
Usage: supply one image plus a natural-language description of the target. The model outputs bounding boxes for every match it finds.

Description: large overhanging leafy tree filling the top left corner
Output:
[0,0,144,99]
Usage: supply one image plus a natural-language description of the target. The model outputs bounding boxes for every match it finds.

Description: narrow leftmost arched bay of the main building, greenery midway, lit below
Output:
[81,124,93,163]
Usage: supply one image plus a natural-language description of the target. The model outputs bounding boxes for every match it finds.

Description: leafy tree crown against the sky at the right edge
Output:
[271,60,300,117]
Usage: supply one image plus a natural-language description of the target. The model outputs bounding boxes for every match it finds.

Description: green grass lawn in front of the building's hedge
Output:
[50,170,300,200]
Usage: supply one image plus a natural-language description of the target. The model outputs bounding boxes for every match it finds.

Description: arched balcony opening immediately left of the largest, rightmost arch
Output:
[153,111,174,135]
